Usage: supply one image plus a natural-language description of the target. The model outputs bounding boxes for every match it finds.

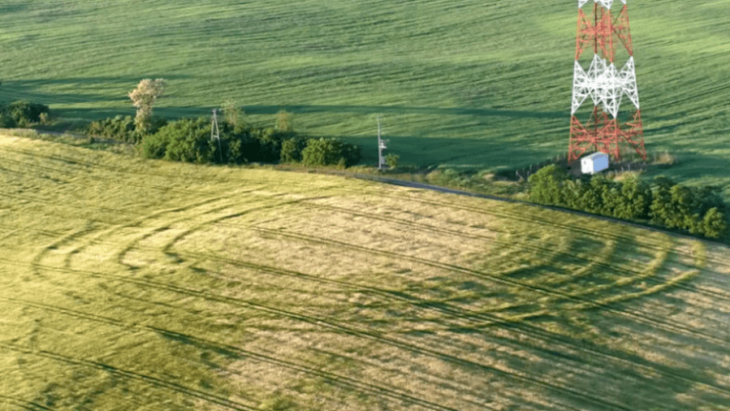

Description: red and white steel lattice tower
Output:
[568,0,646,162]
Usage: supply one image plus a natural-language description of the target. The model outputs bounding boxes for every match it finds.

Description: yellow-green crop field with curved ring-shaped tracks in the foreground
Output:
[0,137,730,411]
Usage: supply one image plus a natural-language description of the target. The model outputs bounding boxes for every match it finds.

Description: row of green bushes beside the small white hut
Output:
[529,165,728,238]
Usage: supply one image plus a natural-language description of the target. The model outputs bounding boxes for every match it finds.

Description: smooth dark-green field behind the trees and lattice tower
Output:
[0,0,730,196]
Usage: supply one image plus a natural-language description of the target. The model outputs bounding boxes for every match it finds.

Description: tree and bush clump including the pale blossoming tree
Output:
[87,79,361,167]
